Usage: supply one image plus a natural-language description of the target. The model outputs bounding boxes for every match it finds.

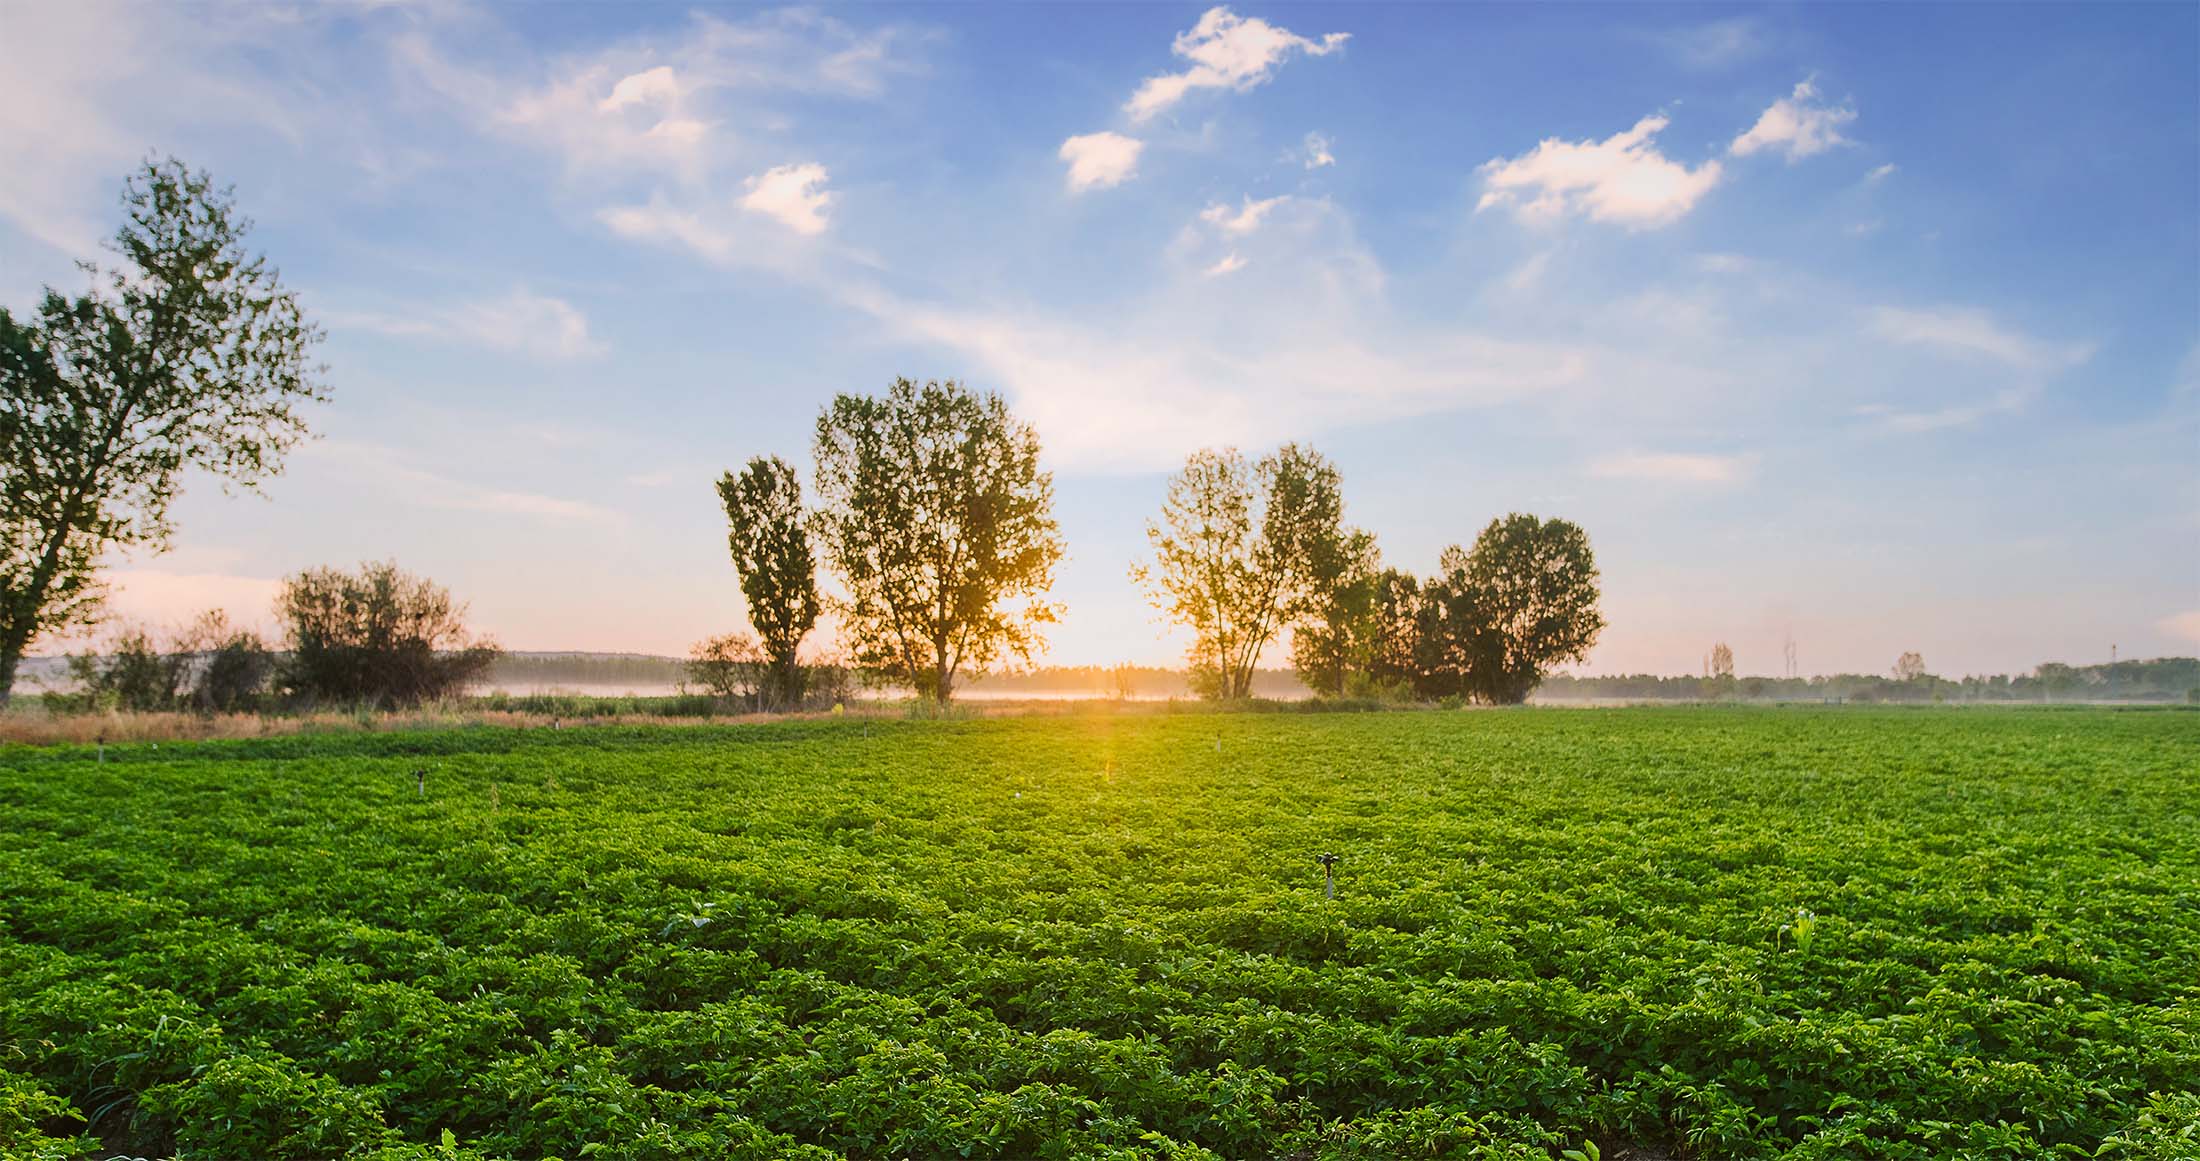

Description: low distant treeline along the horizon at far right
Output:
[1536,657,2200,701]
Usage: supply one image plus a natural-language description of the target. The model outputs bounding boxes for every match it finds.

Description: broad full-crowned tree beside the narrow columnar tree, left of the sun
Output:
[816,378,1063,701]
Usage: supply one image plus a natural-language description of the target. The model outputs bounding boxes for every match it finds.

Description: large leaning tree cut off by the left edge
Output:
[0,158,326,704]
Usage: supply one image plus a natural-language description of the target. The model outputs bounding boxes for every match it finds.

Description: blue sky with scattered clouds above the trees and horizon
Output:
[0,2,2200,675]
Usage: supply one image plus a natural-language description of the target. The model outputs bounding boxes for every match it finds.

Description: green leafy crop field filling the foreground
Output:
[0,708,2200,1159]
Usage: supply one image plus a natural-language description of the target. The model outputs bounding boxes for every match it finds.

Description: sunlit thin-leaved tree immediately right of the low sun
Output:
[1131,444,1346,699]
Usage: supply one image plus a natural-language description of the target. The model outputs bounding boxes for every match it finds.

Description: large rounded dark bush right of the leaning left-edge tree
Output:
[275,561,499,708]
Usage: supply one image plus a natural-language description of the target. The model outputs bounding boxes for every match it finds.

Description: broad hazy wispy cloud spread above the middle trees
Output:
[847,198,1582,473]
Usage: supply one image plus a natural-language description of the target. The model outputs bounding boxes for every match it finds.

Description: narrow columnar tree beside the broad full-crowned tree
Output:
[717,455,821,706]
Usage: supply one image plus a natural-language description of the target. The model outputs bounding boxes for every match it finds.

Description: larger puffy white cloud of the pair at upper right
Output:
[1474,114,1720,229]
